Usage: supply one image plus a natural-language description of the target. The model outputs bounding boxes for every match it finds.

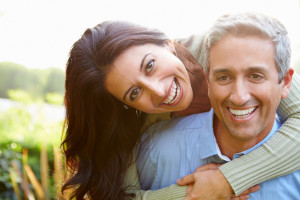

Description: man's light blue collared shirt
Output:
[137,110,300,200]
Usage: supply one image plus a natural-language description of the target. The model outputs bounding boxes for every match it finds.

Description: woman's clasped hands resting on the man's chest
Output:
[177,163,259,200]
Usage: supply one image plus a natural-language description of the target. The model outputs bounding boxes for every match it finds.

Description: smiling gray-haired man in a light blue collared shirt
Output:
[138,13,300,200]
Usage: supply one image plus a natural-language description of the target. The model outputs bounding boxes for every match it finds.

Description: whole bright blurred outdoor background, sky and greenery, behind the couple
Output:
[0,0,300,200]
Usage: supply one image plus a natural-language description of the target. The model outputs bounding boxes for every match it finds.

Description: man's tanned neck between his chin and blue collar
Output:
[213,115,275,159]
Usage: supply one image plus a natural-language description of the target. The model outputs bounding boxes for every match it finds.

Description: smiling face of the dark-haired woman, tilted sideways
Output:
[105,43,193,113]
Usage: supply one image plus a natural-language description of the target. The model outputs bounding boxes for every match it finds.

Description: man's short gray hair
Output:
[198,13,291,82]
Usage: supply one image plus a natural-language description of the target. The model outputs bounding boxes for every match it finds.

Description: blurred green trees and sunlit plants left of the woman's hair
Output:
[0,62,65,199]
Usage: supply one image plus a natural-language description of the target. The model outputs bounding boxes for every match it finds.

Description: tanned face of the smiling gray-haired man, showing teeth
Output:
[208,36,292,143]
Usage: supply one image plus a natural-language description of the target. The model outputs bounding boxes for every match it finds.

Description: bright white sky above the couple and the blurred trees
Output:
[0,0,300,70]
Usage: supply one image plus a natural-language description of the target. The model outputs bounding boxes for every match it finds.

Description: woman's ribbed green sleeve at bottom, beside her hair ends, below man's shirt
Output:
[124,154,187,200]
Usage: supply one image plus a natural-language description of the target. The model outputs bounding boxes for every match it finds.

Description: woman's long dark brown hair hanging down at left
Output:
[62,21,199,200]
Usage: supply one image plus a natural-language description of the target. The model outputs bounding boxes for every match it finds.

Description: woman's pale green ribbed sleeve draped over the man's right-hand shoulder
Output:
[219,73,300,195]
